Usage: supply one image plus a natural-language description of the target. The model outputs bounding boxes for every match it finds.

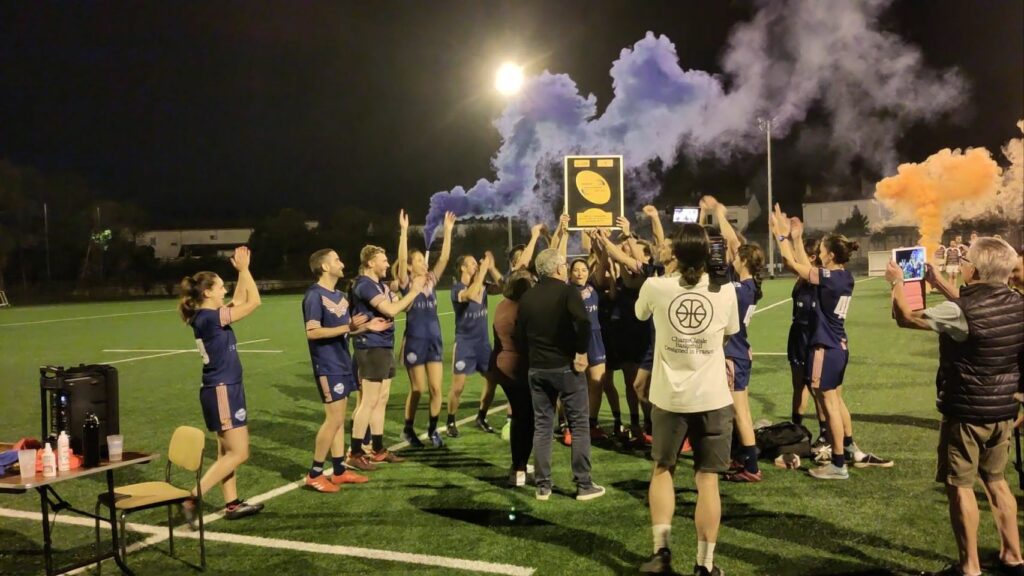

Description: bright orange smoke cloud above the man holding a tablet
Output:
[874,148,1001,254]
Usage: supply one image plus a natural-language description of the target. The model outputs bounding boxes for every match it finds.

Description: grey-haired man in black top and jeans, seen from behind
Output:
[515,248,604,500]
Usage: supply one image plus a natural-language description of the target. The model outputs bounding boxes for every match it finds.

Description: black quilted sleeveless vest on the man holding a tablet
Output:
[935,284,1024,423]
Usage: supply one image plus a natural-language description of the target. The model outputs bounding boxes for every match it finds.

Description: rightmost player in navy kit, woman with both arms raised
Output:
[769,204,893,480]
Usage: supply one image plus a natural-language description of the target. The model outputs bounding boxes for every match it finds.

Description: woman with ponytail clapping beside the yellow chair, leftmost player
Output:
[178,246,263,522]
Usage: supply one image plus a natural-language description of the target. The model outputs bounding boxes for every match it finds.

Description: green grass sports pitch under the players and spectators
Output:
[0,280,1017,576]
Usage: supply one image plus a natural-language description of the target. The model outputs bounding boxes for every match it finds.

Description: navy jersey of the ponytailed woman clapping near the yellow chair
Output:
[191,306,242,386]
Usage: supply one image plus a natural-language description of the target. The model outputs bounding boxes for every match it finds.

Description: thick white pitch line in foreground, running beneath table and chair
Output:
[0,508,534,576]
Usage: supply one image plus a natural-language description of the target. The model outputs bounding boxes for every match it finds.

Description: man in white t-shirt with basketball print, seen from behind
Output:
[636,224,739,576]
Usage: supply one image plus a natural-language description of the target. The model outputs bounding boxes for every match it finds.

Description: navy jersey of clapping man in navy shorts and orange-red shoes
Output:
[302,284,352,376]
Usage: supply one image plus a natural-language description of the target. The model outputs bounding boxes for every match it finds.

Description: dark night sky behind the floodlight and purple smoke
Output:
[0,0,1024,224]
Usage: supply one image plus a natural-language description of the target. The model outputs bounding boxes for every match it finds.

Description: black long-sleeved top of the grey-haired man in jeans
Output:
[515,277,591,369]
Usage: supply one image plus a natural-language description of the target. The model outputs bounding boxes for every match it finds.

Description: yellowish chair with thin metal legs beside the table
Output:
[96,426,206,574]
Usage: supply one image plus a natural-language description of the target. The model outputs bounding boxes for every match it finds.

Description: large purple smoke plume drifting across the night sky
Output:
[424,0,967,244]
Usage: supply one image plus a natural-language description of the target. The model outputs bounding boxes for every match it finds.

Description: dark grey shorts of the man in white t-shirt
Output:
[650,405,735,472]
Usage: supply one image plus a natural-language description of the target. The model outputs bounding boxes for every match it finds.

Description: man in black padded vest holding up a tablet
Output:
[886,238,1024,576]
